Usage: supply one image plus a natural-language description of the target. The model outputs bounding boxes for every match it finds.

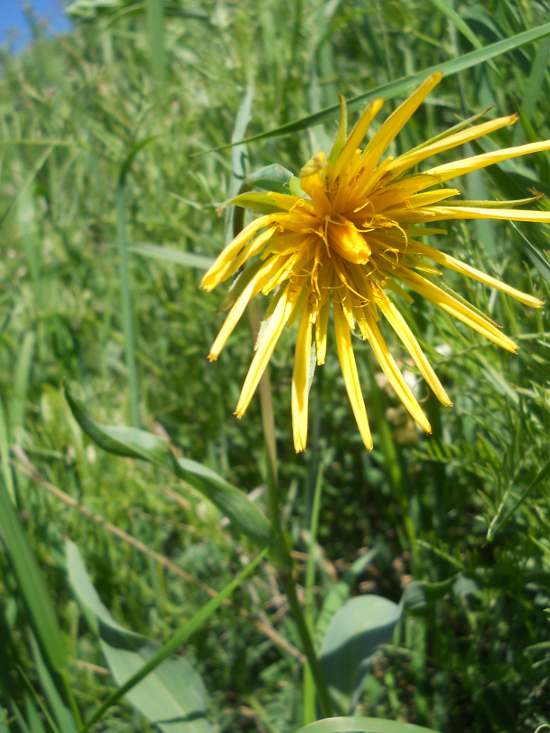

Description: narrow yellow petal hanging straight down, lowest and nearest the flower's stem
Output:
[292,305,313,453]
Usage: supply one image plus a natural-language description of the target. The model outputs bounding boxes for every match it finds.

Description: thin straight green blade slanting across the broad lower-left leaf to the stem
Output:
[80,547,268,733]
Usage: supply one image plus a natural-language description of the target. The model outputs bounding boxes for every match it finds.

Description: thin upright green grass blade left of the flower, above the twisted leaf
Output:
[116,181,140,428]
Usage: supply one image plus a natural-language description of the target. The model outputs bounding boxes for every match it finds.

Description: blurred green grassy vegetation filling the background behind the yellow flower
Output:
[0,0,550,733]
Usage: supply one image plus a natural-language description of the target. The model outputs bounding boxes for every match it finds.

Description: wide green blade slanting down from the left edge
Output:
[0,476,67,672]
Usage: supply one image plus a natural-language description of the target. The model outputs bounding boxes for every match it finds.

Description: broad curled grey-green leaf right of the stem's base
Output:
[319,595,401,712]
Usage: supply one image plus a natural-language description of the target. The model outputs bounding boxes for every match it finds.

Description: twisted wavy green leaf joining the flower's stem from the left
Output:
[65,387,292,567]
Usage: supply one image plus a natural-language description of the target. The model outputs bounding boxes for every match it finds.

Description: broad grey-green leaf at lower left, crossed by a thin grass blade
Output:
[66,541,213,733]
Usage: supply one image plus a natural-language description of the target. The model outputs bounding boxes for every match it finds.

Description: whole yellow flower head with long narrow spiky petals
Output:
[201,73,550,451]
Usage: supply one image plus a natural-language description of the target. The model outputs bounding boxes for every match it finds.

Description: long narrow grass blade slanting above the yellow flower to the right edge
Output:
[201,23,550,155]
